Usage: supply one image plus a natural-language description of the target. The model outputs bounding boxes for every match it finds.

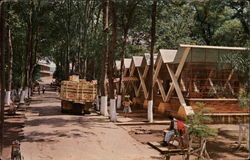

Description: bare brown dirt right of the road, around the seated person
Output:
[122,125,248,160]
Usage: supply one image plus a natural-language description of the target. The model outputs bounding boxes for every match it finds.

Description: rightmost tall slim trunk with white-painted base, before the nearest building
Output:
[148,0,157,122]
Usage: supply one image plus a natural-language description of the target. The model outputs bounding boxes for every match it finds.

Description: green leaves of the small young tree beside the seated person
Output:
[186,103,217,138]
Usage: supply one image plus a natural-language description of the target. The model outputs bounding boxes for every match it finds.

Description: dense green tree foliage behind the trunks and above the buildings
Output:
[3,0,250,85]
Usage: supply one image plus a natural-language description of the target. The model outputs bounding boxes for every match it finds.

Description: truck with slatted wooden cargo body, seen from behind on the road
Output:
[60,75,96,114]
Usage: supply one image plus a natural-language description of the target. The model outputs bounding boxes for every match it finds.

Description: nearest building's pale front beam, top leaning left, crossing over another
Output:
[166,64,187,107]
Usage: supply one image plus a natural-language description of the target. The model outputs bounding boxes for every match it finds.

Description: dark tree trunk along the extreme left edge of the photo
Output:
[0,1,4,155]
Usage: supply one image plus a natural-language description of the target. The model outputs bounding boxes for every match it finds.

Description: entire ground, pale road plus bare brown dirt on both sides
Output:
[4,89,248,160]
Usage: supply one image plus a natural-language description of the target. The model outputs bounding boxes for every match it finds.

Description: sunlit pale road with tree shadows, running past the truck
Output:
[21,92,161,160]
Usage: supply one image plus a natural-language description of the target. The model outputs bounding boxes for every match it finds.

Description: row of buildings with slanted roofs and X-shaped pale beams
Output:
[115,45,250,123]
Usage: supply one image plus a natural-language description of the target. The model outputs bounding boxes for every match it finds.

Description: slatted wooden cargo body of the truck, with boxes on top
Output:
[60,76,96,104]
